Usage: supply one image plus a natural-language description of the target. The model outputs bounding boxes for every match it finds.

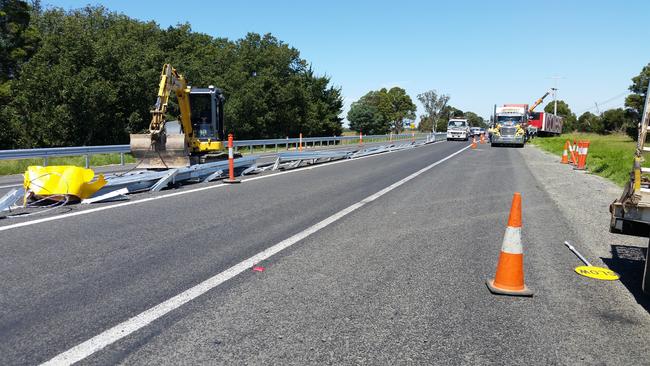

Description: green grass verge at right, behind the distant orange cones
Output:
[531,133,636,187]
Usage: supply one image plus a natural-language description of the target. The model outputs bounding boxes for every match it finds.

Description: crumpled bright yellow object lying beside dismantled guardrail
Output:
[23,165,106,199]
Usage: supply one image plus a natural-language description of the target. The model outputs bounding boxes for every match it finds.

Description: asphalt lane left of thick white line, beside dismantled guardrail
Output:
[0,142,466,364]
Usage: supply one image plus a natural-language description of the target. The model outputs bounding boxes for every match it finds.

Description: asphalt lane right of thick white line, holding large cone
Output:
[83,146,650,365]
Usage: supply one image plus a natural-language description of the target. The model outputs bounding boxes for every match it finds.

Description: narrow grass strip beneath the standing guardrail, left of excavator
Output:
[0,154,135,175]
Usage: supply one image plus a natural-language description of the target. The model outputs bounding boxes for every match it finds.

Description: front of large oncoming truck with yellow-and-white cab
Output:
[490,104,528,147]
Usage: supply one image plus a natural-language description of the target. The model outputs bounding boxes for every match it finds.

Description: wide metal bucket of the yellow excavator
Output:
[130,134,190,169]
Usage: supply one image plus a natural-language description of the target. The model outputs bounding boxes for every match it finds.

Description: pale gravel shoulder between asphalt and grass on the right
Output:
[519,145,650,311]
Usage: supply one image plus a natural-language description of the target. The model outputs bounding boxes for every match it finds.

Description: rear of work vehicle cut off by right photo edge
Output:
[609,82,650,294]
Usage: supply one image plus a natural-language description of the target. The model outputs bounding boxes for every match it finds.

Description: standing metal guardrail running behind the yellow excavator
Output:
[0,133,430,168]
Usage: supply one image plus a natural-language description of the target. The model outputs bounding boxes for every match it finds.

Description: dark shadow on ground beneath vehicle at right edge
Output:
[601,245,650,313]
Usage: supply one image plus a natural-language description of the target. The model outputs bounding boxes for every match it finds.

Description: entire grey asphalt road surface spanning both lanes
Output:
[0,142,650,365]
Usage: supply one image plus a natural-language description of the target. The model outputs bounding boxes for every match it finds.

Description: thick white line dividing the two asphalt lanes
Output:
[43,146,469,365]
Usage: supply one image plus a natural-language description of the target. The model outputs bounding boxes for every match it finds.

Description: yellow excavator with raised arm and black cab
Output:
[130,64,225,169]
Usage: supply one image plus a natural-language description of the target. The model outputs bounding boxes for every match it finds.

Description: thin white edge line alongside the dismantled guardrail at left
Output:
[0,140,454,232]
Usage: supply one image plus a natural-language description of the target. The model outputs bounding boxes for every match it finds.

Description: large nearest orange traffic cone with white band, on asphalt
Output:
[487,192,533,296]
